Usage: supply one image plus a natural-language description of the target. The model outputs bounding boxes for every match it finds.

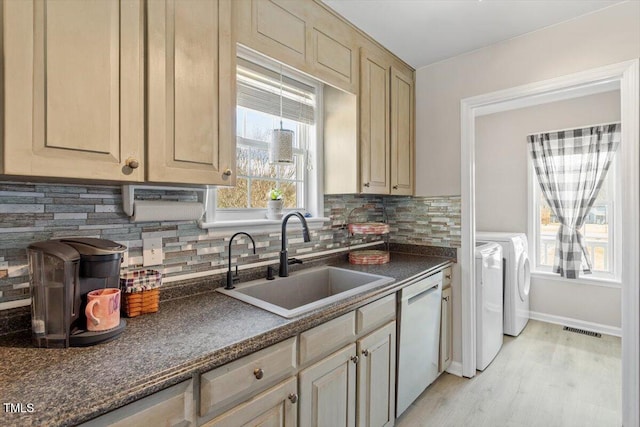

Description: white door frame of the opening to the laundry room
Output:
[460,59,640,426]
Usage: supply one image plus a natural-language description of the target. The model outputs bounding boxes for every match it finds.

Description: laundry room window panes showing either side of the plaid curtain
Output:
[529,125,622,282]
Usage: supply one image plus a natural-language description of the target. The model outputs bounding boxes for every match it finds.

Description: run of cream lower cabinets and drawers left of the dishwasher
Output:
[77,294,404,427]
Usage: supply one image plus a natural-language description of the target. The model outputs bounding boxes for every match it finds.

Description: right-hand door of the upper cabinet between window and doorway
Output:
[389,67,415,196]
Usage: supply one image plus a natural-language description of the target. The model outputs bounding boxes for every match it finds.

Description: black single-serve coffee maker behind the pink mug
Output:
[27,237,127,347]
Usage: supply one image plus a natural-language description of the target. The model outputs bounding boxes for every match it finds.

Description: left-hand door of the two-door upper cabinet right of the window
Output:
[360,49,391,194]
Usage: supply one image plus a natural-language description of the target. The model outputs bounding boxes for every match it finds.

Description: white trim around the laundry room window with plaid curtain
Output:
[527,132,622,288]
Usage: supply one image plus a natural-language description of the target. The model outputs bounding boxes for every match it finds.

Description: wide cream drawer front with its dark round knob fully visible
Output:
[199,337,296,417]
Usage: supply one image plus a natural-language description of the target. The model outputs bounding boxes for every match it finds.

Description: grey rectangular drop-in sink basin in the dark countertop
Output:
[216,266,395,318]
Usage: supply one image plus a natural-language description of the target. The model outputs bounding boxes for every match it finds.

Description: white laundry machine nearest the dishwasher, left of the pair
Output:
[475,243,504,371]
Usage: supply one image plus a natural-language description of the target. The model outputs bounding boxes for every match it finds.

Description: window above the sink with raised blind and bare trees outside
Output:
[215,47,322,226]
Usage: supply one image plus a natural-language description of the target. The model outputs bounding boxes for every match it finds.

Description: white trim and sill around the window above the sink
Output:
[199,45,330,232]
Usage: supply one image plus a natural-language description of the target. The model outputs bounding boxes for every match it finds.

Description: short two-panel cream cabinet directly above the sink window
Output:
[234,0,358,93]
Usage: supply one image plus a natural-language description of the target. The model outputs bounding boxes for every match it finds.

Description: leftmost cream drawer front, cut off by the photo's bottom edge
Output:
[82,380,195,427]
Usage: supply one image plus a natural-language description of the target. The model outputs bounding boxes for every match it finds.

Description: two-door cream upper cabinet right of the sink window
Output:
[360,42,415,195]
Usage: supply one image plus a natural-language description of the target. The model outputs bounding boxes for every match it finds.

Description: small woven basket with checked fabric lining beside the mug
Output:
[120,270,162,317]
